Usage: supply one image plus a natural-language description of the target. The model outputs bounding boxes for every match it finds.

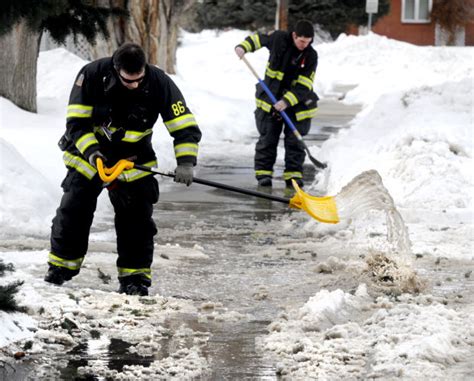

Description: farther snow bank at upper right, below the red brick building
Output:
[316,33,474,104]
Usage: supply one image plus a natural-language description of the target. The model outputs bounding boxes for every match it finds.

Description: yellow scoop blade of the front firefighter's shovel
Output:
[290,180,339,224]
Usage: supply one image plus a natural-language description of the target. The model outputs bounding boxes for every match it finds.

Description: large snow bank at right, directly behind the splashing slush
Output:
[321,78,474,210]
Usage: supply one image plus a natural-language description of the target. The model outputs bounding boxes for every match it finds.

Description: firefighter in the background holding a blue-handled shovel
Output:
[235,20,318,187]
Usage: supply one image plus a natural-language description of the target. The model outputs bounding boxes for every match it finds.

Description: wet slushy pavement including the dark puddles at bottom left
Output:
[1,94,359,380]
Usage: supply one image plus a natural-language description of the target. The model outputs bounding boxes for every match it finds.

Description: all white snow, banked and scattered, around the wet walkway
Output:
[0,30,474,380]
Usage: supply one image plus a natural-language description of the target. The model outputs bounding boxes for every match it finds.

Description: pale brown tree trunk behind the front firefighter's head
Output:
[92,0,194,74]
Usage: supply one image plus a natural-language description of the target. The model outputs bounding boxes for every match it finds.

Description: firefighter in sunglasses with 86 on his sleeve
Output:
[45,43,201,295]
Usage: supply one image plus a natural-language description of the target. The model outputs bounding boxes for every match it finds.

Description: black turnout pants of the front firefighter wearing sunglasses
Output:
[49,169,159,284]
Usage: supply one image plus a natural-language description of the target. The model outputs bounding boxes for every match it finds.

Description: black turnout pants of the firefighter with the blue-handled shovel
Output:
[255,109,311,180]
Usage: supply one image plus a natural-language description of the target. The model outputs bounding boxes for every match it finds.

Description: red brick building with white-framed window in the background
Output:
[348,0,474,46]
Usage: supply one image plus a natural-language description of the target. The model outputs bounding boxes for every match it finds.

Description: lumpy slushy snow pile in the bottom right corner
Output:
[259,285,474,380]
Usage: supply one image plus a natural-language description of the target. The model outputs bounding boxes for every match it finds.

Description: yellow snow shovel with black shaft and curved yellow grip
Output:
[97,158,339,224]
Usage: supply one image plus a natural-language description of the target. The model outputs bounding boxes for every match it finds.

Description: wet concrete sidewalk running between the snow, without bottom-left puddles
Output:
[150,94,360,380]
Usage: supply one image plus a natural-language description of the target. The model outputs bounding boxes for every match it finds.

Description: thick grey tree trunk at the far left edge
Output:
[0,22,41,112]
